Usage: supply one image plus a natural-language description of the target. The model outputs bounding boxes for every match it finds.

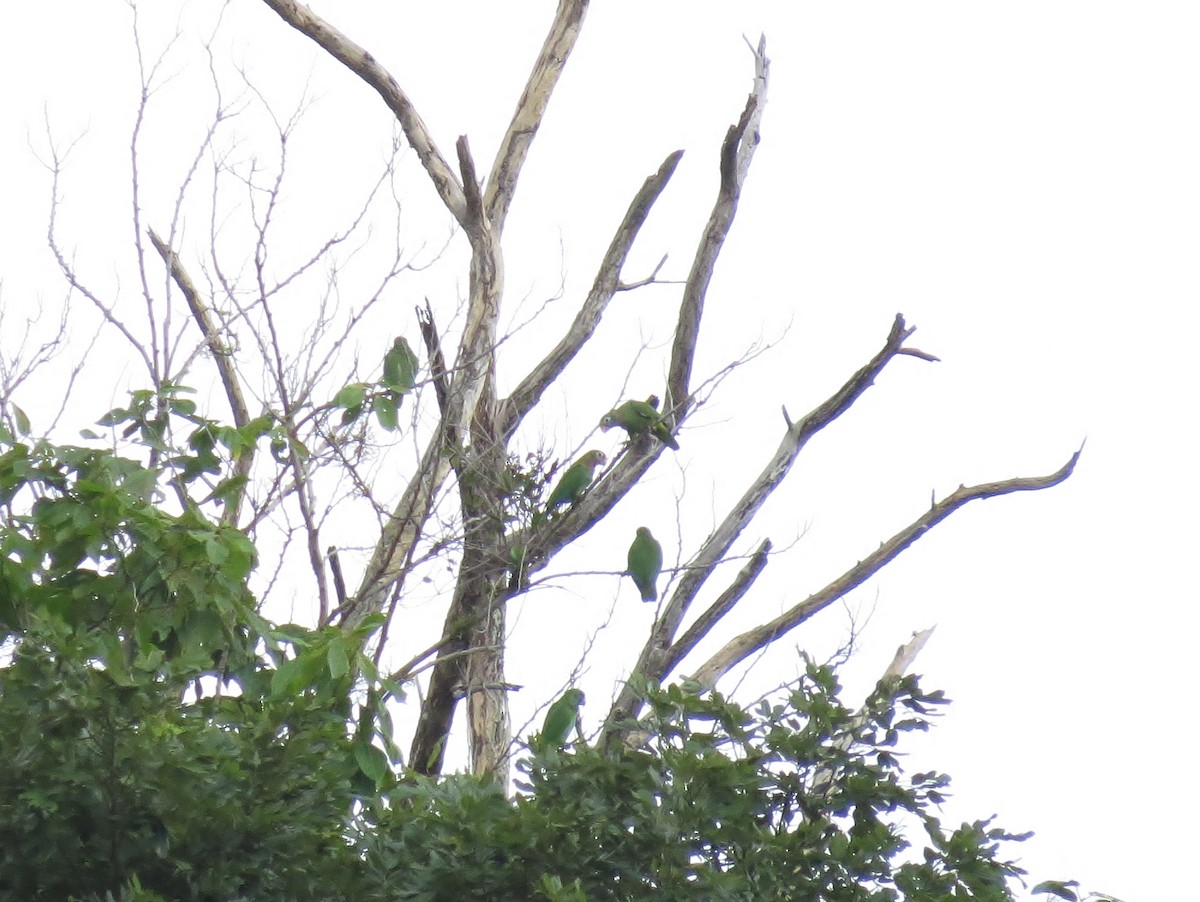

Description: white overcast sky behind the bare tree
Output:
[0,0,1200,902]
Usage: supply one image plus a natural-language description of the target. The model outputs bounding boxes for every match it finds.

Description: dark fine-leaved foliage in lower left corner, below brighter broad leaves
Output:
[0,630,355,900]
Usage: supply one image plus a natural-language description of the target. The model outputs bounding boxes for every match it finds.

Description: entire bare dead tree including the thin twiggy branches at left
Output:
[23,0,1079,781]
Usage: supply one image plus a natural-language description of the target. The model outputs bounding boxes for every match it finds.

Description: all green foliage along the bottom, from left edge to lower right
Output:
[0,411,1104,902]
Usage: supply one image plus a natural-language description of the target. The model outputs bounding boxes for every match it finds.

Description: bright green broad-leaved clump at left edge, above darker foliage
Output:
[0,419,256,671]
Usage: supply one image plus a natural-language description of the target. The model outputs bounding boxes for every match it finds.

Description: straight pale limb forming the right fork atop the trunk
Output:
[484,0,588,235]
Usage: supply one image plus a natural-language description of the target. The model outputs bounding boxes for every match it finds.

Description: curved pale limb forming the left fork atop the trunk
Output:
[263,0,467,228]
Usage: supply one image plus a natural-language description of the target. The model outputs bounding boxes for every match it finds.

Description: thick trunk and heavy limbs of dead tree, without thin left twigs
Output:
[248,0,1075,776]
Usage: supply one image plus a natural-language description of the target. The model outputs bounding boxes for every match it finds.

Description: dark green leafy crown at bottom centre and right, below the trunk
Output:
[364,667,1070,902]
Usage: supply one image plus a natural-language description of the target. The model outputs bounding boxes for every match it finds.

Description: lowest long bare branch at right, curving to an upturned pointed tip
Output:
[695,449,1082,686]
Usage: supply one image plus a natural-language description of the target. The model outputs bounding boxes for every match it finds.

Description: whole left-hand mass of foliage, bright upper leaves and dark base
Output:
[0,425,386,900]
